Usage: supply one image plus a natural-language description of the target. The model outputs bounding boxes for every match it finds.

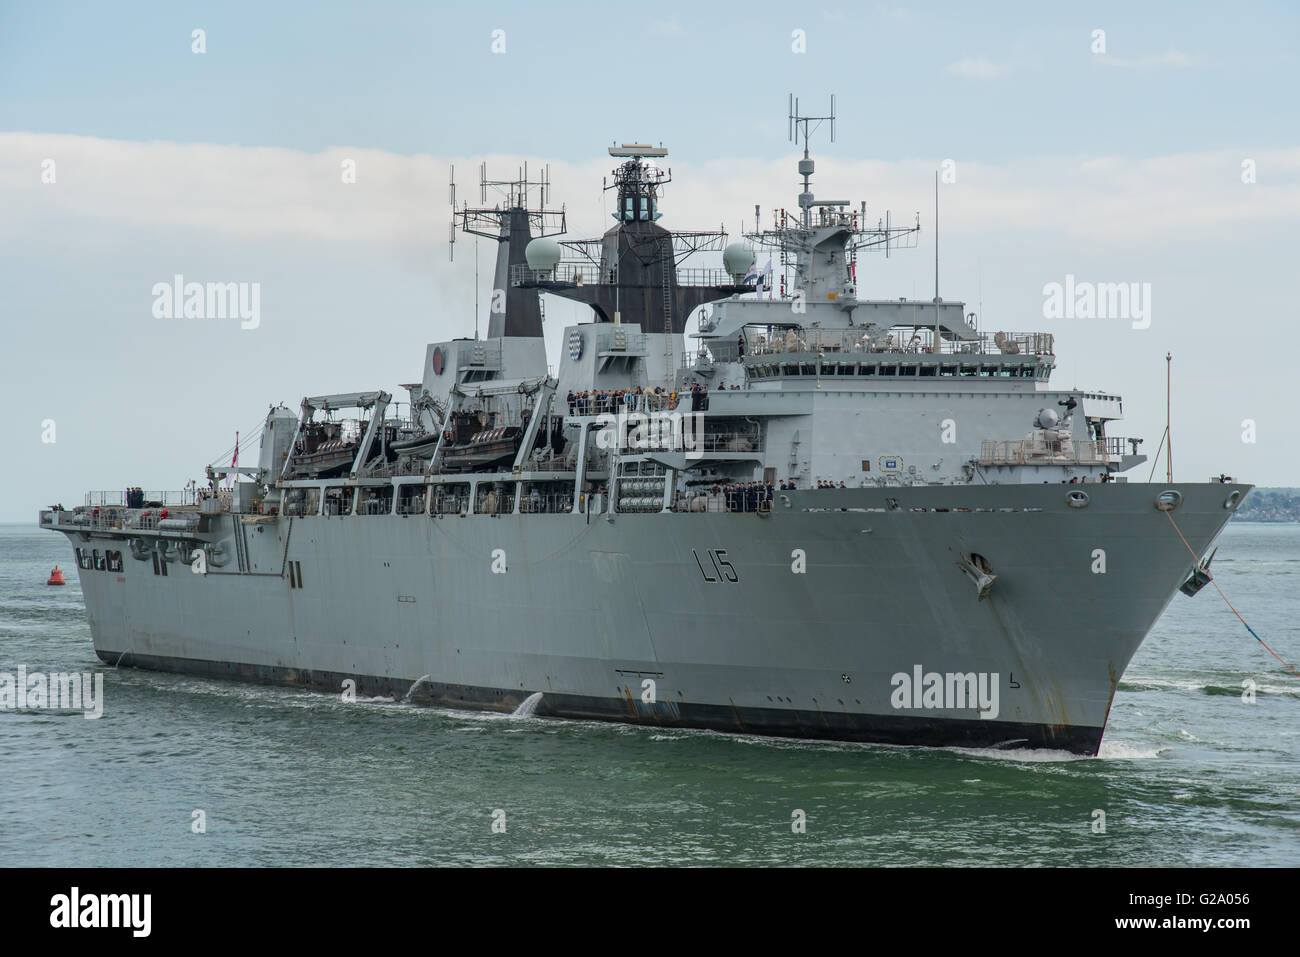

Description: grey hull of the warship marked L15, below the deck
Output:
[43,484,1249,754]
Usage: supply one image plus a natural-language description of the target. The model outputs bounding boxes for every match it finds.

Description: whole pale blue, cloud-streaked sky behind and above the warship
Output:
[0,0,1300,521]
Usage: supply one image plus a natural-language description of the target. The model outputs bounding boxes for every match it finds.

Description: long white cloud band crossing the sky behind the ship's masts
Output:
[0,133,1300,248]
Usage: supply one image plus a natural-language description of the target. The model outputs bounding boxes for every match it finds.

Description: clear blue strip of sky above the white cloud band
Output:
[0,3,1300,161]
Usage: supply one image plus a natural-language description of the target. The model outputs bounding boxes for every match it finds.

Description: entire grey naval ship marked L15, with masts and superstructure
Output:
[39,100,1251,754]
